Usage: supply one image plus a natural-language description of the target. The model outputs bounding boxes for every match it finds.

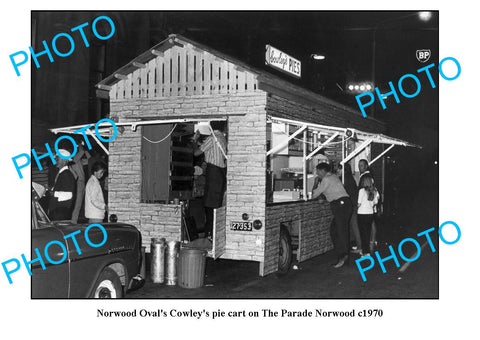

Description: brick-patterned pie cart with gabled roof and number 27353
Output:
[56,35,416,276]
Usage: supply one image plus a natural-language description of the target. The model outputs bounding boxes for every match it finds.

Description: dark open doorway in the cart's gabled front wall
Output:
[141,120,227,258]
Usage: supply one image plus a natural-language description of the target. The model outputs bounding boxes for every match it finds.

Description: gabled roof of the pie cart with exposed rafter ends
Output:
[96,34,384,125]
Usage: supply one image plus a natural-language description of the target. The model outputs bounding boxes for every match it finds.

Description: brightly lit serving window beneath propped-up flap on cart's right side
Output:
[266,117,418,203]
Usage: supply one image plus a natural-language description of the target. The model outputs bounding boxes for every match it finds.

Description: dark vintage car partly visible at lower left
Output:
[31,189,144,298]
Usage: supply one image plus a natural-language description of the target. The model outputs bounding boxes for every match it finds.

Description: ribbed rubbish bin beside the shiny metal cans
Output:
[178,248,207,288]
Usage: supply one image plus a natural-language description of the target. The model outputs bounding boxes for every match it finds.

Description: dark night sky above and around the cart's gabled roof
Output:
[32,11,438,145]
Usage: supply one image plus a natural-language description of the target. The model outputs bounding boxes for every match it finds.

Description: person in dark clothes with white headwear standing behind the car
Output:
[48,149,77,221]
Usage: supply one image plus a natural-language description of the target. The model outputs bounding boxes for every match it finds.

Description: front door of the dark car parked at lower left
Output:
[31,202,69,298]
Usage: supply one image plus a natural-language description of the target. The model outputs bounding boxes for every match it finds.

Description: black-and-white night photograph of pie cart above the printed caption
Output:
[31,11,439,298]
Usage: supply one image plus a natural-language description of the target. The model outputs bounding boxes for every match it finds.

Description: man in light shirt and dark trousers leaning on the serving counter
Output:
[312,163,352,268]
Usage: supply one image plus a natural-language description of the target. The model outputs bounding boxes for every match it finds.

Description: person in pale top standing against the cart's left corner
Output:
[85,162,107,223]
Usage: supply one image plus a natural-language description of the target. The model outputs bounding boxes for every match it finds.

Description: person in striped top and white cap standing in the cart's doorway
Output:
[194,122,227,240]
